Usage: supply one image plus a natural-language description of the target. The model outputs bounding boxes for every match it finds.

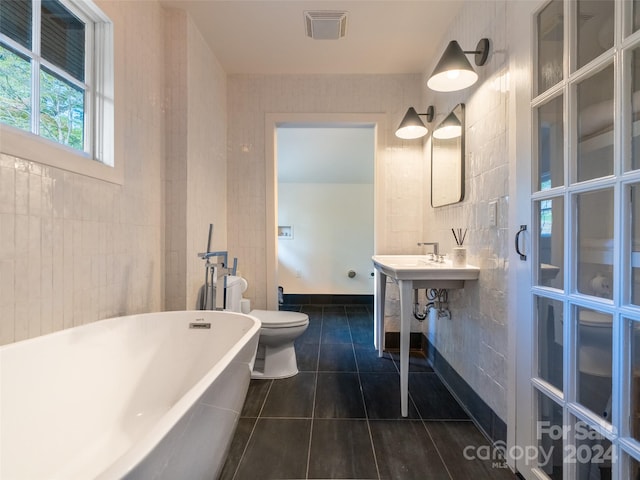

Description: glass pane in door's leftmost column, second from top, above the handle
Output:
[534,95,564,191]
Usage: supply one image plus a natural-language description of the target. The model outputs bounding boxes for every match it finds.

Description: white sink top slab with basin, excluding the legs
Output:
[373,255,480,288]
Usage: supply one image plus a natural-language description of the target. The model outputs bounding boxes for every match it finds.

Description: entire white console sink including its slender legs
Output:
[373,255,480,417]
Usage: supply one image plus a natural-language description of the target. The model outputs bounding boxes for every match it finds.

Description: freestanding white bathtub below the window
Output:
[0,311,260,480]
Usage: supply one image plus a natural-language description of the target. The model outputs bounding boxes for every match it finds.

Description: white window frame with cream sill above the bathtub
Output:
[0,0,119,184]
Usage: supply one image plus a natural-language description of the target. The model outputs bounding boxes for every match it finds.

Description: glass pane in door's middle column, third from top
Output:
[576,188,614,300]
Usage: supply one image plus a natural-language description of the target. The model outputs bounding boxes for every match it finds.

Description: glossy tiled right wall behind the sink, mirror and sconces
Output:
[423,1,510,421]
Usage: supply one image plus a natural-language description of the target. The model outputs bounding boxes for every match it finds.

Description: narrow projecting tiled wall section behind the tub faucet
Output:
[165,9,227,310]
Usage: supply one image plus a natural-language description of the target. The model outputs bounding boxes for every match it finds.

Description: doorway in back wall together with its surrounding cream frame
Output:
[265,114,385,310]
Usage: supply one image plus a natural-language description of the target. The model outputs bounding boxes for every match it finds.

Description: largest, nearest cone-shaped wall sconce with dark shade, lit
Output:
[427,38,489,92]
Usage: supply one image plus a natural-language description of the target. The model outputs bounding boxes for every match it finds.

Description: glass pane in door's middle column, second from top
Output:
[576,65,614,182]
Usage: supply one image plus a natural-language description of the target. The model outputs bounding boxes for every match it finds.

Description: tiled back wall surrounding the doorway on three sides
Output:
[228,75,425,308]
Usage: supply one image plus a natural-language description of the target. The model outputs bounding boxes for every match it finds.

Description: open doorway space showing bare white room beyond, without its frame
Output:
[276,124,375,303]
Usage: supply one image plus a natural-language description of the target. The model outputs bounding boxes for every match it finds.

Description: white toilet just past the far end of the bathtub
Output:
[225,275,309,379]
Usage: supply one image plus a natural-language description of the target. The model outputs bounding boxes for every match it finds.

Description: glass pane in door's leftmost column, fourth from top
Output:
[536,297,564,391]
